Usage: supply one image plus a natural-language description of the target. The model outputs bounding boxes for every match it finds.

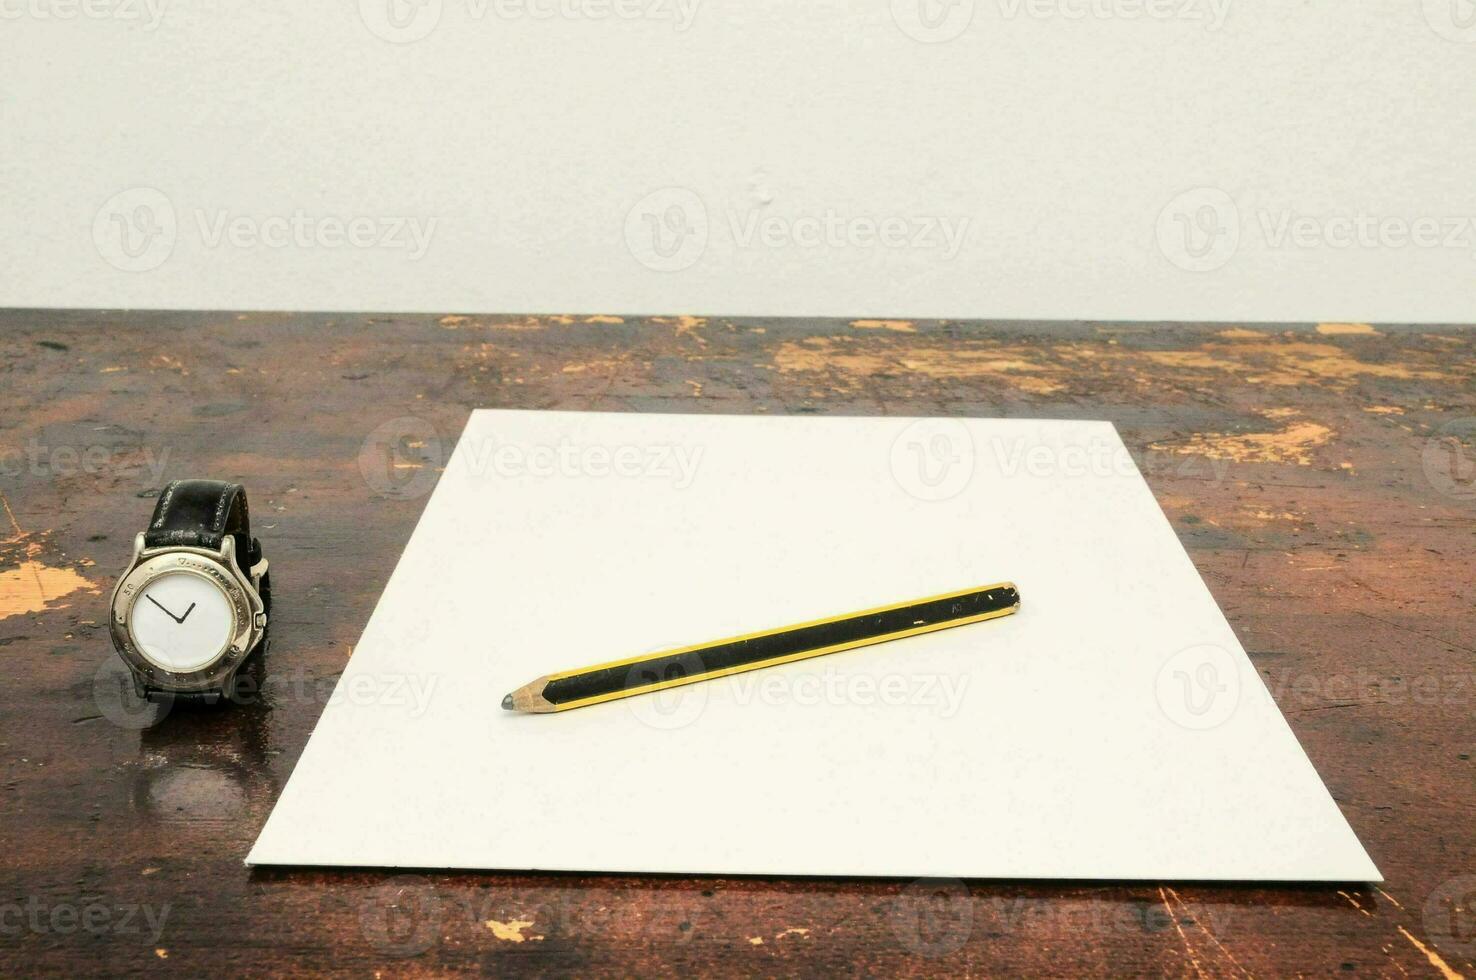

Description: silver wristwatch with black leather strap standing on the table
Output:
[109,480,272,703]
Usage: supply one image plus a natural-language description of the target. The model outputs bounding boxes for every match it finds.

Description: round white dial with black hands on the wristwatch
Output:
[128,571,236,673]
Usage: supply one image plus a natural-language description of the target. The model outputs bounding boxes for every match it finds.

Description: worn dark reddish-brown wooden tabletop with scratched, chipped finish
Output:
[0,311,1476,977]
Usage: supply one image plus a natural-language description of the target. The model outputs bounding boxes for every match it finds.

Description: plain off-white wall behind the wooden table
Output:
[0,0,1476,322]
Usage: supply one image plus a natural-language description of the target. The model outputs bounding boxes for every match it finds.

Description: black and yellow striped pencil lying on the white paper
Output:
[502,582,1020,714]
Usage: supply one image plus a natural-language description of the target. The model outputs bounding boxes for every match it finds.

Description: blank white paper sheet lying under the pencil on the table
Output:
[248,412,1380,881]
